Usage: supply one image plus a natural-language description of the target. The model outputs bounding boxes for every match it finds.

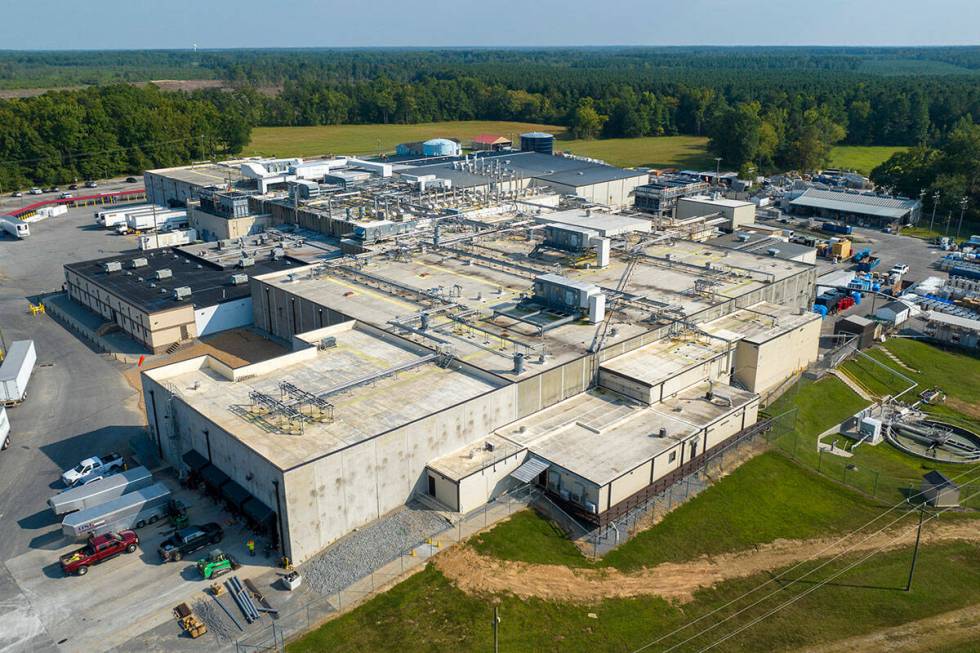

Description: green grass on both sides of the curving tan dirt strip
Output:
[287,454,980,653]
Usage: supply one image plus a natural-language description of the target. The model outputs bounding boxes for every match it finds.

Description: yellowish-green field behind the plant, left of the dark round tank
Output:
[244,120,565,157]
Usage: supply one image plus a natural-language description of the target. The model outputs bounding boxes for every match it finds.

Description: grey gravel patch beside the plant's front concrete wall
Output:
[301,506,448,595]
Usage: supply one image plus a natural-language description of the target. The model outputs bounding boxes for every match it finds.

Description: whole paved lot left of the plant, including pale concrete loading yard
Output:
[0,207,295,653]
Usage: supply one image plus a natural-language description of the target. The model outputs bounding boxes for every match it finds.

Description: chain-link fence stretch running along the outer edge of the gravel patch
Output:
[235,485,542,653]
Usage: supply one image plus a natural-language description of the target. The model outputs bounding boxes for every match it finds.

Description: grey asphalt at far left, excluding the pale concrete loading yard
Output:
[0,207,144,652]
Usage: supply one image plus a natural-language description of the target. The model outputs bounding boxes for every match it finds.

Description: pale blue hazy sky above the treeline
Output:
[0,0,980,50]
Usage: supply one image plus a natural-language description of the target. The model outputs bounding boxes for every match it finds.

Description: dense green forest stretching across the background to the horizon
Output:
[0,48,980,196]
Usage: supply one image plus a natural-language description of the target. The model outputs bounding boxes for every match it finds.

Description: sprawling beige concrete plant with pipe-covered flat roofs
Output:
[130,143,821,562]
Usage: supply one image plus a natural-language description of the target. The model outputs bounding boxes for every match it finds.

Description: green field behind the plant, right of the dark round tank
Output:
[555,136,715,170]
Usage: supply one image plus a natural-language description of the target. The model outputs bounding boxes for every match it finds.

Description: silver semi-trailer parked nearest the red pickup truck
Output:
[61,483,171,539]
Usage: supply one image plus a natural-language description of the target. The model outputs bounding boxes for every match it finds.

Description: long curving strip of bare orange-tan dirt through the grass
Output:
[435,522,980,603]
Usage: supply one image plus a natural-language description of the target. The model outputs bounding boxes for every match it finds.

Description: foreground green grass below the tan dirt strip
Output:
[287,542,980,653]
